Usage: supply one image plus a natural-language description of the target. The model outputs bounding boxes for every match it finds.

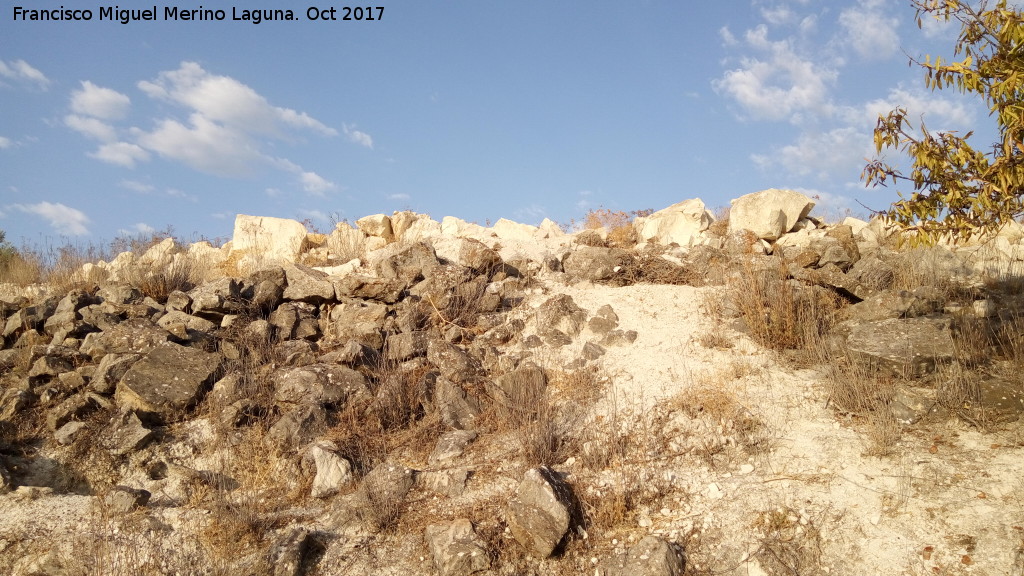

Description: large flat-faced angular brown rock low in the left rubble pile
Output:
[116,342,220,418]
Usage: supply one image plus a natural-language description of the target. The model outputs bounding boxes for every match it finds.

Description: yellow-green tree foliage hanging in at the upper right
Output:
[861,0,1024,242]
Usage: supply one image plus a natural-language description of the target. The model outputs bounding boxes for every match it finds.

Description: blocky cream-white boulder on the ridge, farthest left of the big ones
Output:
[231,214,306,264]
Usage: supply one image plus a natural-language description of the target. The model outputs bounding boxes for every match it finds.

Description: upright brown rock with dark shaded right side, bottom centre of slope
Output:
[508,466,575,558]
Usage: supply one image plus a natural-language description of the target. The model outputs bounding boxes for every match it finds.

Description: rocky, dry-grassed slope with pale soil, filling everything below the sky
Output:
[0,191,1024,576]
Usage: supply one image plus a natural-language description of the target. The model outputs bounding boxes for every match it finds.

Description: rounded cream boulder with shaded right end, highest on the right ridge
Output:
[729,188,814,241]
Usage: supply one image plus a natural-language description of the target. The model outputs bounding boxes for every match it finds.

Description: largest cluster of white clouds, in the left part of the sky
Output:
[65,61,339,196]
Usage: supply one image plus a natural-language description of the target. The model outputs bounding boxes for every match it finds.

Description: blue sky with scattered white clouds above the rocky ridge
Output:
[0,0,991,244]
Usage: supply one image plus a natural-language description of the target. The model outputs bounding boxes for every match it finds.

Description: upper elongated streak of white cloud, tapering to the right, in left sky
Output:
[138,61,337,135]
